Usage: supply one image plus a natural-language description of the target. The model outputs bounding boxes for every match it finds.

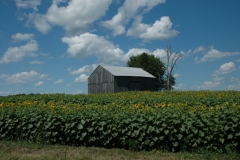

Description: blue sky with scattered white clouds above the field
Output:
[0,0,240,96]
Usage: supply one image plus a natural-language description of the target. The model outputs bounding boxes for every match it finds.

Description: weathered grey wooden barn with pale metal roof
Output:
[88,65,156,94]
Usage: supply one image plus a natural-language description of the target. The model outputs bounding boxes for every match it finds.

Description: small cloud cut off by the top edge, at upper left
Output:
[15,0,42,11]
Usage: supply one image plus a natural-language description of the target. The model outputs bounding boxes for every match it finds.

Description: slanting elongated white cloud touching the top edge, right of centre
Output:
[102,0,165,36]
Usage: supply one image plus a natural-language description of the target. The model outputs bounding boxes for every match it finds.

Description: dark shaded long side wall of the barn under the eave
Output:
[114,76,156,92]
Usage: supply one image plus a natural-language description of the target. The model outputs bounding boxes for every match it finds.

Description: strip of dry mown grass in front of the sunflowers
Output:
[0,141,240,160]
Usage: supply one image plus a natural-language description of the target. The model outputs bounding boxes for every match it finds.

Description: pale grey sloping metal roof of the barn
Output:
[101,65,155,78]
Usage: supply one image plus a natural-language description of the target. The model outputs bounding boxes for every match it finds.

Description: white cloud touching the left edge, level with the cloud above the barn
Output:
[0,40,38,64]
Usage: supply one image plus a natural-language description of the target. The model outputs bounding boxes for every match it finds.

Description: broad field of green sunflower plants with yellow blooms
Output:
[0,91,240,152]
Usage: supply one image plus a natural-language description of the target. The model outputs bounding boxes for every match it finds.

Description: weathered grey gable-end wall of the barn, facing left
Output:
[88,66,114,94]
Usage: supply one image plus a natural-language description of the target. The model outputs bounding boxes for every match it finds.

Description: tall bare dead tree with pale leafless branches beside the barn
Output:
[165,45,182,90]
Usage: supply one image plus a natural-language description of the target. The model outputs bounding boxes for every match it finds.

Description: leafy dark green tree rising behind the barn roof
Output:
[127,53,175,90]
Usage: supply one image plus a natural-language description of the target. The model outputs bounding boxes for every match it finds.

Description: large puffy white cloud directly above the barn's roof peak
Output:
[62,33,125,64]
